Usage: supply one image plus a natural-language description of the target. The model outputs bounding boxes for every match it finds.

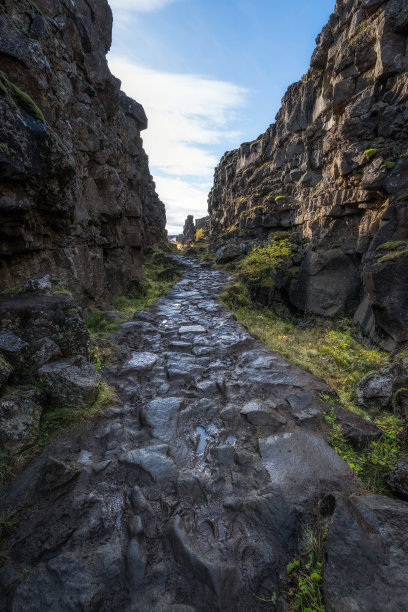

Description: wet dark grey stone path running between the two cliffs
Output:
[0,260,408,612]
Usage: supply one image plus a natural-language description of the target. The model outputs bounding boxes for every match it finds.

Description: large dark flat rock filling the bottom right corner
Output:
[323,495,408,612]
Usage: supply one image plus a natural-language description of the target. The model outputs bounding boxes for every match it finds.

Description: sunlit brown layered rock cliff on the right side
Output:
[209,0,408,348]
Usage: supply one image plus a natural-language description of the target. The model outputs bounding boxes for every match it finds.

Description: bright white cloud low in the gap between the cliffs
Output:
[109,54,248,233]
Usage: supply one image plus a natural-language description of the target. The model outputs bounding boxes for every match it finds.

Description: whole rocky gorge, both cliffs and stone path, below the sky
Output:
[0,0,408,612]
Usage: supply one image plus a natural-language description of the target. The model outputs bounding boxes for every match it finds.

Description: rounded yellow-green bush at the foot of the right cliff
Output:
[238,239,292,283]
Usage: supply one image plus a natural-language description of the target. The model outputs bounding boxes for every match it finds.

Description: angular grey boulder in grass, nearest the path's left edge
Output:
[38,355,101,408]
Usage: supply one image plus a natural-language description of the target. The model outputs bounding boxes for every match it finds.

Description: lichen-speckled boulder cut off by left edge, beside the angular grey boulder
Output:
[0,389,42,455]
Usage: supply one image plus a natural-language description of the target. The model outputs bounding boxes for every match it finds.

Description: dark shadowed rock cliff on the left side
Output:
[0,0,165,306]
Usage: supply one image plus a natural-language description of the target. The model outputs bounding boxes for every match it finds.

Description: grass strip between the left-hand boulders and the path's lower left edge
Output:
[0,382,115,488]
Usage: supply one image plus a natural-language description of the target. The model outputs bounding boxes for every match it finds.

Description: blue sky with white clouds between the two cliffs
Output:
[108,0,335,234]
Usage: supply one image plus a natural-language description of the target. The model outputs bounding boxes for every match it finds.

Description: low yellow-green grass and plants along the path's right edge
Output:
[221,282,404,492]
